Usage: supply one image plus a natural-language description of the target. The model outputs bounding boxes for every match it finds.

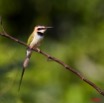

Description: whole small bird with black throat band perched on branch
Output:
[18,26,52,91]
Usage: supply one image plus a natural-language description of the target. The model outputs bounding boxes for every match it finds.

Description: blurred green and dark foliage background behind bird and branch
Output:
[0,0,104,103]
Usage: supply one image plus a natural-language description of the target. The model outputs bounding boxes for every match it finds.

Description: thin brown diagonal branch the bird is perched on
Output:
[0,21,104,96]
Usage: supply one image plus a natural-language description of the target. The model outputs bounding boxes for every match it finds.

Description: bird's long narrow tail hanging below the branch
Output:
[18,49,32,91]
